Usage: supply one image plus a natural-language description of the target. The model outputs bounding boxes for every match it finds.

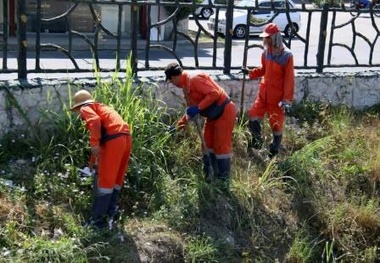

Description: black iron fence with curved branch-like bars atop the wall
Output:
[0,0,380,79]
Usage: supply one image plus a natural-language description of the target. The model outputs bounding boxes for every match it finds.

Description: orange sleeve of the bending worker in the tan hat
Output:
[80,106,101,147]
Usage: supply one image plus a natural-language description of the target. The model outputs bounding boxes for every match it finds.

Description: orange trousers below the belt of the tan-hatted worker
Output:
[97,136,132,194]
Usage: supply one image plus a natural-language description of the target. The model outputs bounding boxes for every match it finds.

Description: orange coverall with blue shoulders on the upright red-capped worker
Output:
[248,48,294,134]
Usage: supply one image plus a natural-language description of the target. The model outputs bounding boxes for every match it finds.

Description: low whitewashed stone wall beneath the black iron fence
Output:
[0,71,380,135]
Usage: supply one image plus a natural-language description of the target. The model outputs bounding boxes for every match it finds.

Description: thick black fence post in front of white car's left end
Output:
[223,0,234,74]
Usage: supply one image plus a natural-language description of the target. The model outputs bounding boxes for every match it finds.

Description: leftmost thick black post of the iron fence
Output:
[17,0,27,79]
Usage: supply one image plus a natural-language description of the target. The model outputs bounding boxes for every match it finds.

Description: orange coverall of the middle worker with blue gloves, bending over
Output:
[179,71,236,159]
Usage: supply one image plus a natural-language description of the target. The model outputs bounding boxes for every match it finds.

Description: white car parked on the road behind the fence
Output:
[207,0,301,38]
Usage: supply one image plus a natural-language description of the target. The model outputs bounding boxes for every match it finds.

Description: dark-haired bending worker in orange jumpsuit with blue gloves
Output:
[165,62,236,181]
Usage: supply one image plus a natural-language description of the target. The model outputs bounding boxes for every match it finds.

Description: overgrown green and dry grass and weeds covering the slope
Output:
[0,61,380,262]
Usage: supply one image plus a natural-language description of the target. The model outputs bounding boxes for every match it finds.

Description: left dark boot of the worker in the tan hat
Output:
[90,194,112,229]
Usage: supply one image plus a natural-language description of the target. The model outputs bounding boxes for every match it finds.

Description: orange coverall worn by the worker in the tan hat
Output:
[80,103,132,194]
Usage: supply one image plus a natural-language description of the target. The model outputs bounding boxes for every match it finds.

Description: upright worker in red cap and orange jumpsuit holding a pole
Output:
[242,23,294,158]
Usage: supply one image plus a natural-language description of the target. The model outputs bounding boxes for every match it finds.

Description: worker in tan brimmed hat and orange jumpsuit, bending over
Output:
[71,90,132,229]
